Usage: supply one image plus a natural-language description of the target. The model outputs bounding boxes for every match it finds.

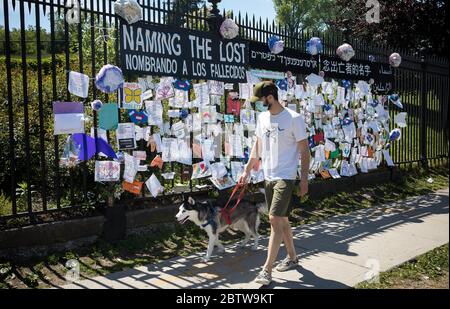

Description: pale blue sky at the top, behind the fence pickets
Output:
[0,0,275,28]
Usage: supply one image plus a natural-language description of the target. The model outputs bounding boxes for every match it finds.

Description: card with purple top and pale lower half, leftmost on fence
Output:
[53,102,84,135]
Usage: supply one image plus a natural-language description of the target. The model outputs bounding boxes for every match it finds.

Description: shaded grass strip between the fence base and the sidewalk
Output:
[0,166,449,288]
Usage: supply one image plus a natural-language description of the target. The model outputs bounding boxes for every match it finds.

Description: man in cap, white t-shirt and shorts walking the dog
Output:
[239,81,310,285]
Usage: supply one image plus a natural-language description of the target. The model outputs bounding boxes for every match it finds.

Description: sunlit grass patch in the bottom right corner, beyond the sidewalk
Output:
[356,244,449,289]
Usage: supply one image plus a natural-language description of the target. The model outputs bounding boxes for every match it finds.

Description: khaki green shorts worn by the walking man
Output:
[264,179,295,217]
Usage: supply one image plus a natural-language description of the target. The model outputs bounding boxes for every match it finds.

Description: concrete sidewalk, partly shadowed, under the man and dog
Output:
[63,188,449,289]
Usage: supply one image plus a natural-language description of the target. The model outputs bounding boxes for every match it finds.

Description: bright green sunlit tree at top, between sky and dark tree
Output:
[273,0,336,36]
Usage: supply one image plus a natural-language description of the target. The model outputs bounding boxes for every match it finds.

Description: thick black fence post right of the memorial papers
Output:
[419,54,428,167]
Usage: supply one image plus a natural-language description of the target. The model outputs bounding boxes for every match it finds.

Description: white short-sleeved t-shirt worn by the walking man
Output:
[256,108,308,181]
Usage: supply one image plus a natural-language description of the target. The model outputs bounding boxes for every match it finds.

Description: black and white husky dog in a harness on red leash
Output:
[175,197,265,261]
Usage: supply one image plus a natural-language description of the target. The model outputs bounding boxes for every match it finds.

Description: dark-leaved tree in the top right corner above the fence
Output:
[330,0,449,55]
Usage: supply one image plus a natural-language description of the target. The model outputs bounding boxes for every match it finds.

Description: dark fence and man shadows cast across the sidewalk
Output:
[62,189,449,288]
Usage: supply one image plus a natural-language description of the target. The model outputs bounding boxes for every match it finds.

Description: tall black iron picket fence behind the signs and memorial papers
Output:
[0,0,449,225]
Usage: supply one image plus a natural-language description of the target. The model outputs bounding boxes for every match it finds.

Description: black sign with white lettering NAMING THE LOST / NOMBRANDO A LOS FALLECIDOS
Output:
[119,22,248,82]
